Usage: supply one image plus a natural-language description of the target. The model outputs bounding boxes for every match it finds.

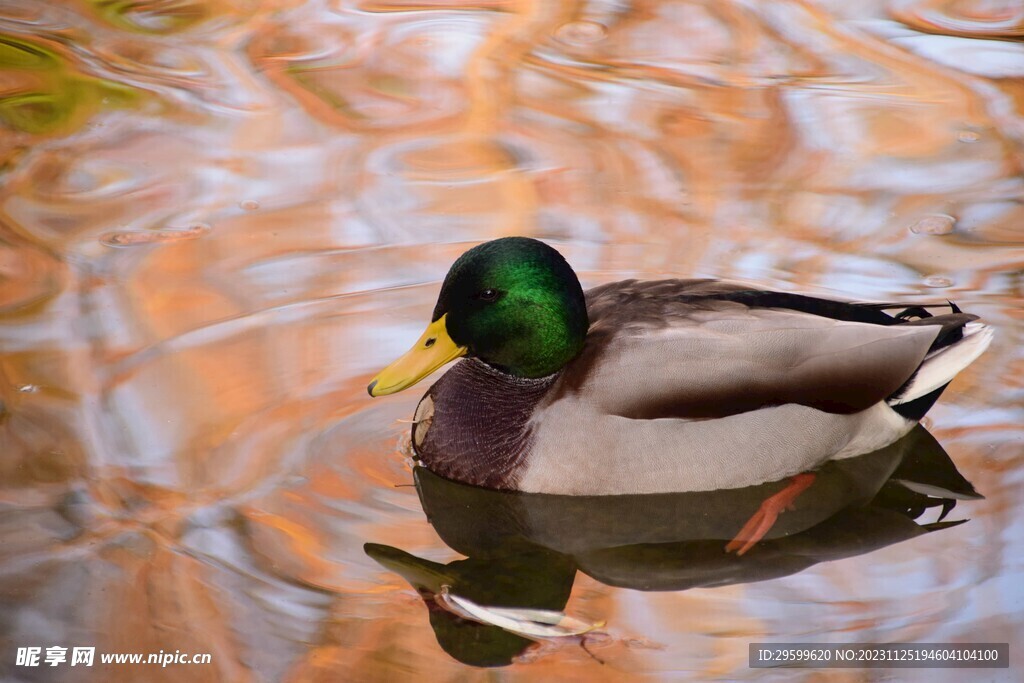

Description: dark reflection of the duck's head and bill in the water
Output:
[364,542,575,667]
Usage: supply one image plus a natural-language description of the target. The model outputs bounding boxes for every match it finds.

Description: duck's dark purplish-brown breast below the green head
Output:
[413,358,557,489]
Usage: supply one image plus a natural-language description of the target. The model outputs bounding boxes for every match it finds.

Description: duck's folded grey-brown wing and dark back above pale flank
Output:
[557,280,975,419]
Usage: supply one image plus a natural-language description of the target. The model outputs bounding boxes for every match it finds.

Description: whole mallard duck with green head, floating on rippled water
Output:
[369,238,991,499]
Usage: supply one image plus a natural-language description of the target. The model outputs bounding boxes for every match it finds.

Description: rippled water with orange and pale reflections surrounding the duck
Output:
[0,0,1024,681]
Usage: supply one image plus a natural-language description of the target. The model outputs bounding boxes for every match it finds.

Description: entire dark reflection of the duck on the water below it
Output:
[366,426,982,667]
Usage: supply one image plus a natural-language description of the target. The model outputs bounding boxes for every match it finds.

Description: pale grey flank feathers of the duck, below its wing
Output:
[517,397,913,496]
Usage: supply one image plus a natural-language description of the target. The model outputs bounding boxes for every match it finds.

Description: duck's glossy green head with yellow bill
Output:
[369,238,590,396]
